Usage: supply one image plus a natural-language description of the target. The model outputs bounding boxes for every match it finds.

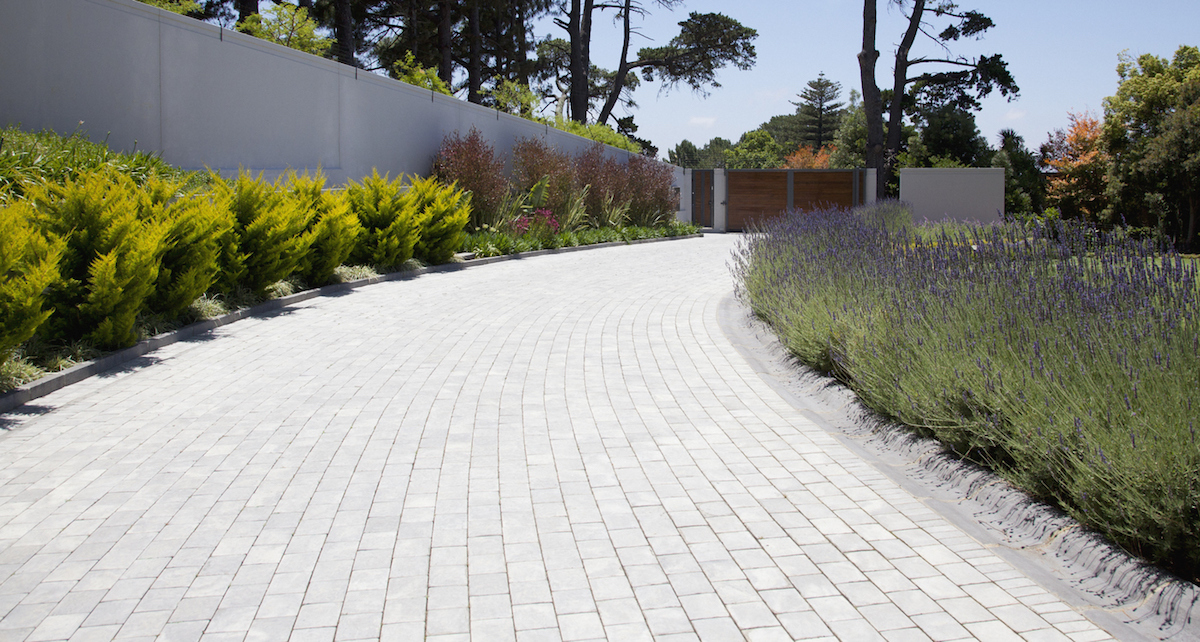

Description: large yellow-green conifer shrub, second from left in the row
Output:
[29,169,167,349]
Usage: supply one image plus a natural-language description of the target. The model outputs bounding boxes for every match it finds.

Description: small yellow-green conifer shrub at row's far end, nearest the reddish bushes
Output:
[403,176,470,264]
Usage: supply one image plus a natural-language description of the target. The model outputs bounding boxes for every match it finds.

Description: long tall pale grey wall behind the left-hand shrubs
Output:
[0,0,652,187]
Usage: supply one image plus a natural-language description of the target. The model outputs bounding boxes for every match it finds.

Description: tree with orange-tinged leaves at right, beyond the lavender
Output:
[1042,112,1110,222]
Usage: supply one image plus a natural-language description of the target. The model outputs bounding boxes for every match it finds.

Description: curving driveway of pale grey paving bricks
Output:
[0,235,1105,642]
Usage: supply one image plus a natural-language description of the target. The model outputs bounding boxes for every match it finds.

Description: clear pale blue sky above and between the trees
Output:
[539,0,1200,156]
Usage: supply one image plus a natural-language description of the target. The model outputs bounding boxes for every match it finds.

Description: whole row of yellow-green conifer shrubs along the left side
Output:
[0,148,470,364]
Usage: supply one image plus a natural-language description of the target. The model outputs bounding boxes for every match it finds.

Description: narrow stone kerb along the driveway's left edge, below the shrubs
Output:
[0,233,703,413]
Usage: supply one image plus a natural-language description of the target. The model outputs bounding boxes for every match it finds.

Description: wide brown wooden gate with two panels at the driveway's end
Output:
[720,169,866,232]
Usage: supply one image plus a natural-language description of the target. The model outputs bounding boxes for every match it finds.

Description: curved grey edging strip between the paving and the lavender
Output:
[719,295,1200,640]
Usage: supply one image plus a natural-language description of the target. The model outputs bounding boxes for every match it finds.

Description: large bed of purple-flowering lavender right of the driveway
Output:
[733,205,1200,580]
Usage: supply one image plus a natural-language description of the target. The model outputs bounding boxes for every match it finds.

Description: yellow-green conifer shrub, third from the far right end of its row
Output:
[289,172,362,286]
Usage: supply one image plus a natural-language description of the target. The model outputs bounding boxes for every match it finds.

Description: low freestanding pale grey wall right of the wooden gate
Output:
[900,167,1004,223]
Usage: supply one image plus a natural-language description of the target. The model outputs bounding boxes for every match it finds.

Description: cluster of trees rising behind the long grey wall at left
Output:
[143,0,757,157]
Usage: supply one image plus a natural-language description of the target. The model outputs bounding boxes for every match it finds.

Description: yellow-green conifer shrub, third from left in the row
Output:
[142,179,234,318]
